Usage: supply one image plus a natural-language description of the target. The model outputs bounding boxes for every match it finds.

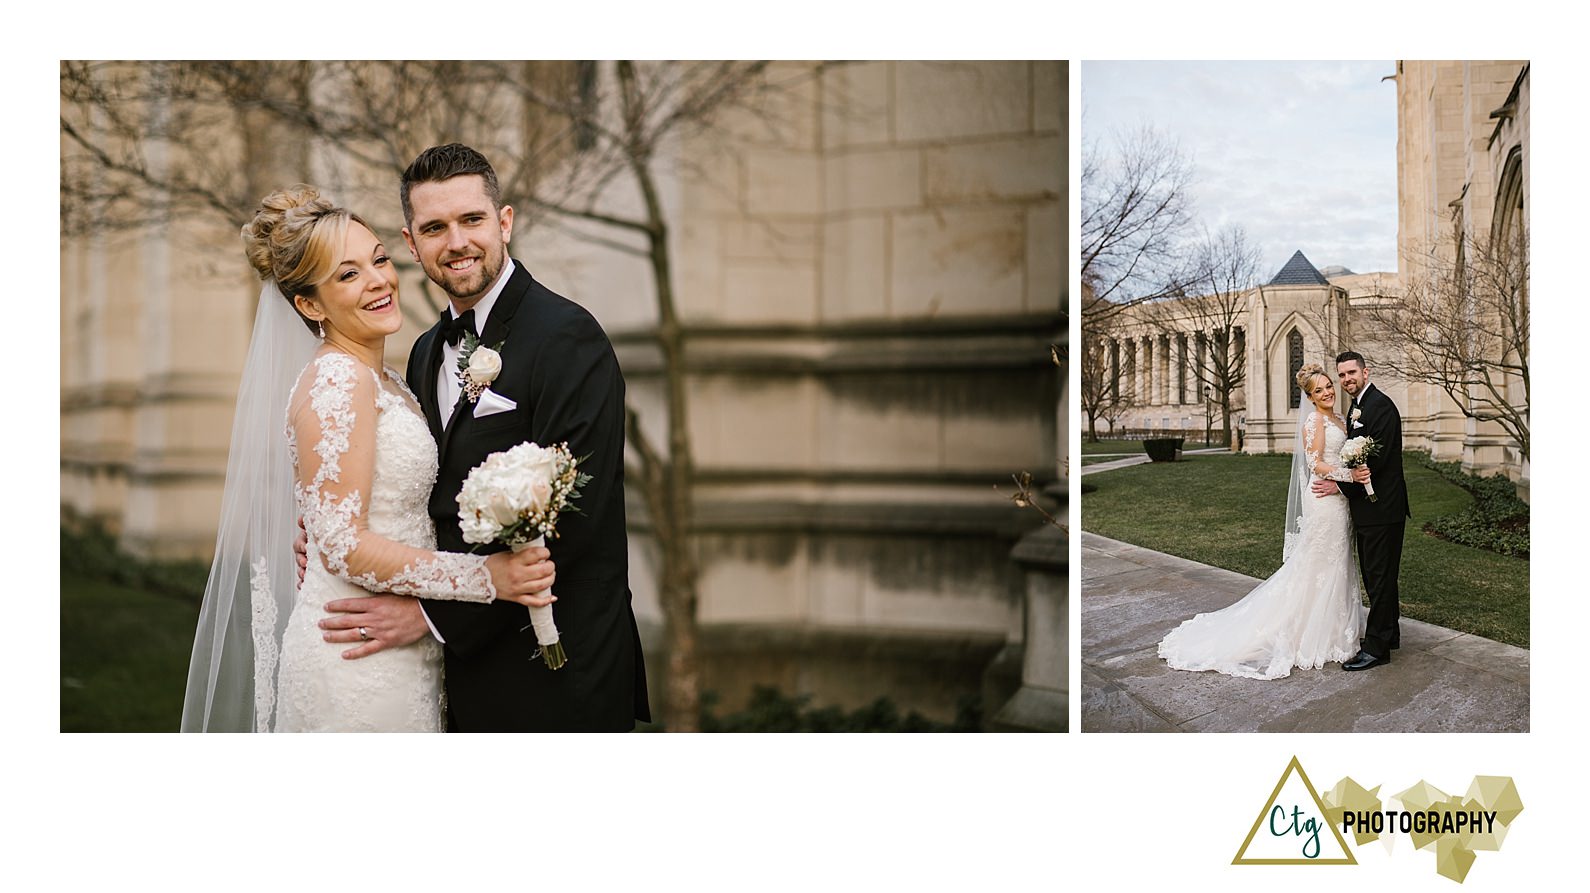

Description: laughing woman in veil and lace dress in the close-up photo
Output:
[181,186,555,731]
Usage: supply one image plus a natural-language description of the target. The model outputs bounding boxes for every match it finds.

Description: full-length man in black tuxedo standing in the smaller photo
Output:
[1313,351,1410,671]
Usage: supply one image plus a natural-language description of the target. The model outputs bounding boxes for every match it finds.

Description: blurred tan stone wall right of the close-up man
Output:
[619,62,1065,718]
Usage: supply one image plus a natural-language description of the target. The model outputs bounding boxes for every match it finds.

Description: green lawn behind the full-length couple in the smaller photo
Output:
[1081,442,1530,647]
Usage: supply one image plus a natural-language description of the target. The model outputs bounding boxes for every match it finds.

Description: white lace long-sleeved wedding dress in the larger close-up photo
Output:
[271,353,494,731]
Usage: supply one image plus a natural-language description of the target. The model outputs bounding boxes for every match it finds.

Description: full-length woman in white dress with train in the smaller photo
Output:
[1159,364,1367,678]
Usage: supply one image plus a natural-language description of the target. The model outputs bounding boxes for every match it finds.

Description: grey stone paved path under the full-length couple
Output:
[1081,532,1530,733]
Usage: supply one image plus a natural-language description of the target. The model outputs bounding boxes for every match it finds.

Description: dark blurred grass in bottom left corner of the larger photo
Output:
[60,567,199,733]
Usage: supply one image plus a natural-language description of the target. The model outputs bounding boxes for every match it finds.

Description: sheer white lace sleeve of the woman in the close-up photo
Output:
[288,353,496,602]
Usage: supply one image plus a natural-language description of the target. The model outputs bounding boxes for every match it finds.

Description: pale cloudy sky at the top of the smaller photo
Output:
[1081,60,1396,278]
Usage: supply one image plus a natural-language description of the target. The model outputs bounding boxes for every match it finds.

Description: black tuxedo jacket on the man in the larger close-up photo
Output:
[407,262,652,731]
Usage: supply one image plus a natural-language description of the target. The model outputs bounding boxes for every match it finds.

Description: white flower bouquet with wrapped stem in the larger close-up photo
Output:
[458,443,591,669]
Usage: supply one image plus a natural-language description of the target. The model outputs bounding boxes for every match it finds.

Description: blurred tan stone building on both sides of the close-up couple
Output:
[62,62,1068,728]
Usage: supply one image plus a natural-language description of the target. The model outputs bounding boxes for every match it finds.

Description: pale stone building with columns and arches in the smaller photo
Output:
[1107,62,1530,494]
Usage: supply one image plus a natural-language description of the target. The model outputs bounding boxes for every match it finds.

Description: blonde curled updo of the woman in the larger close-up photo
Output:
[242,183,375,331]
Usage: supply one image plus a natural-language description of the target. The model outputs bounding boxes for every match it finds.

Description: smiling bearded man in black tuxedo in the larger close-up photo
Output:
[321,143,652,731]
